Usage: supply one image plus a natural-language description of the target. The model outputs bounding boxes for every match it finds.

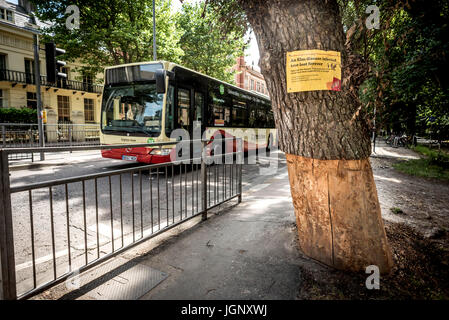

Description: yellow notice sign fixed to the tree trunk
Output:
[287,50,341,92]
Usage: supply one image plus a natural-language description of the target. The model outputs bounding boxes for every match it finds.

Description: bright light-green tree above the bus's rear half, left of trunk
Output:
[178,2,246,83]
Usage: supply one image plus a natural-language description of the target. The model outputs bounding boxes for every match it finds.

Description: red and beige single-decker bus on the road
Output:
[100,61,277,163]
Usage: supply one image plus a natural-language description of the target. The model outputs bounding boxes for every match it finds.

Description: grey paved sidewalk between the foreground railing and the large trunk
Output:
[36,169,312,300]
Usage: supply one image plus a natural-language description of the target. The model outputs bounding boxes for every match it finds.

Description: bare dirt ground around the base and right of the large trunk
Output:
[298,144,449,299]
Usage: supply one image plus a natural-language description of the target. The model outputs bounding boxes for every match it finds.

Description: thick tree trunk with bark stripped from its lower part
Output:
[240,0,392,272]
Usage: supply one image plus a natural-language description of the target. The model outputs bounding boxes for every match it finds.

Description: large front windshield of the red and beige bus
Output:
[102,83,163,137]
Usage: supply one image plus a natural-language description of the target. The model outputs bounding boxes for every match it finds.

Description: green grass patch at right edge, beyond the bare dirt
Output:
[393,145,449,181]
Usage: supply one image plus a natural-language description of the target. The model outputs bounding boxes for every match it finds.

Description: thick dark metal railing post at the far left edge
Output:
[0,150,17,300]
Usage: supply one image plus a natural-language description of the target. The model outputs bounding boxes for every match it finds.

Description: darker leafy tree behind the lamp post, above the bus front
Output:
[33,0,183,79]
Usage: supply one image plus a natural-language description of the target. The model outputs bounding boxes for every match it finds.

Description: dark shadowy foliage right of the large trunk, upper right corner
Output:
[341,0,449,140]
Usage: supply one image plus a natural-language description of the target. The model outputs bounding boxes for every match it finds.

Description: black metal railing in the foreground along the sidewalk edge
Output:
[0,139,243,299]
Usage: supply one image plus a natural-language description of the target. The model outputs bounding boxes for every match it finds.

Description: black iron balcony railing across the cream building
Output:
[0,69,103,94]
